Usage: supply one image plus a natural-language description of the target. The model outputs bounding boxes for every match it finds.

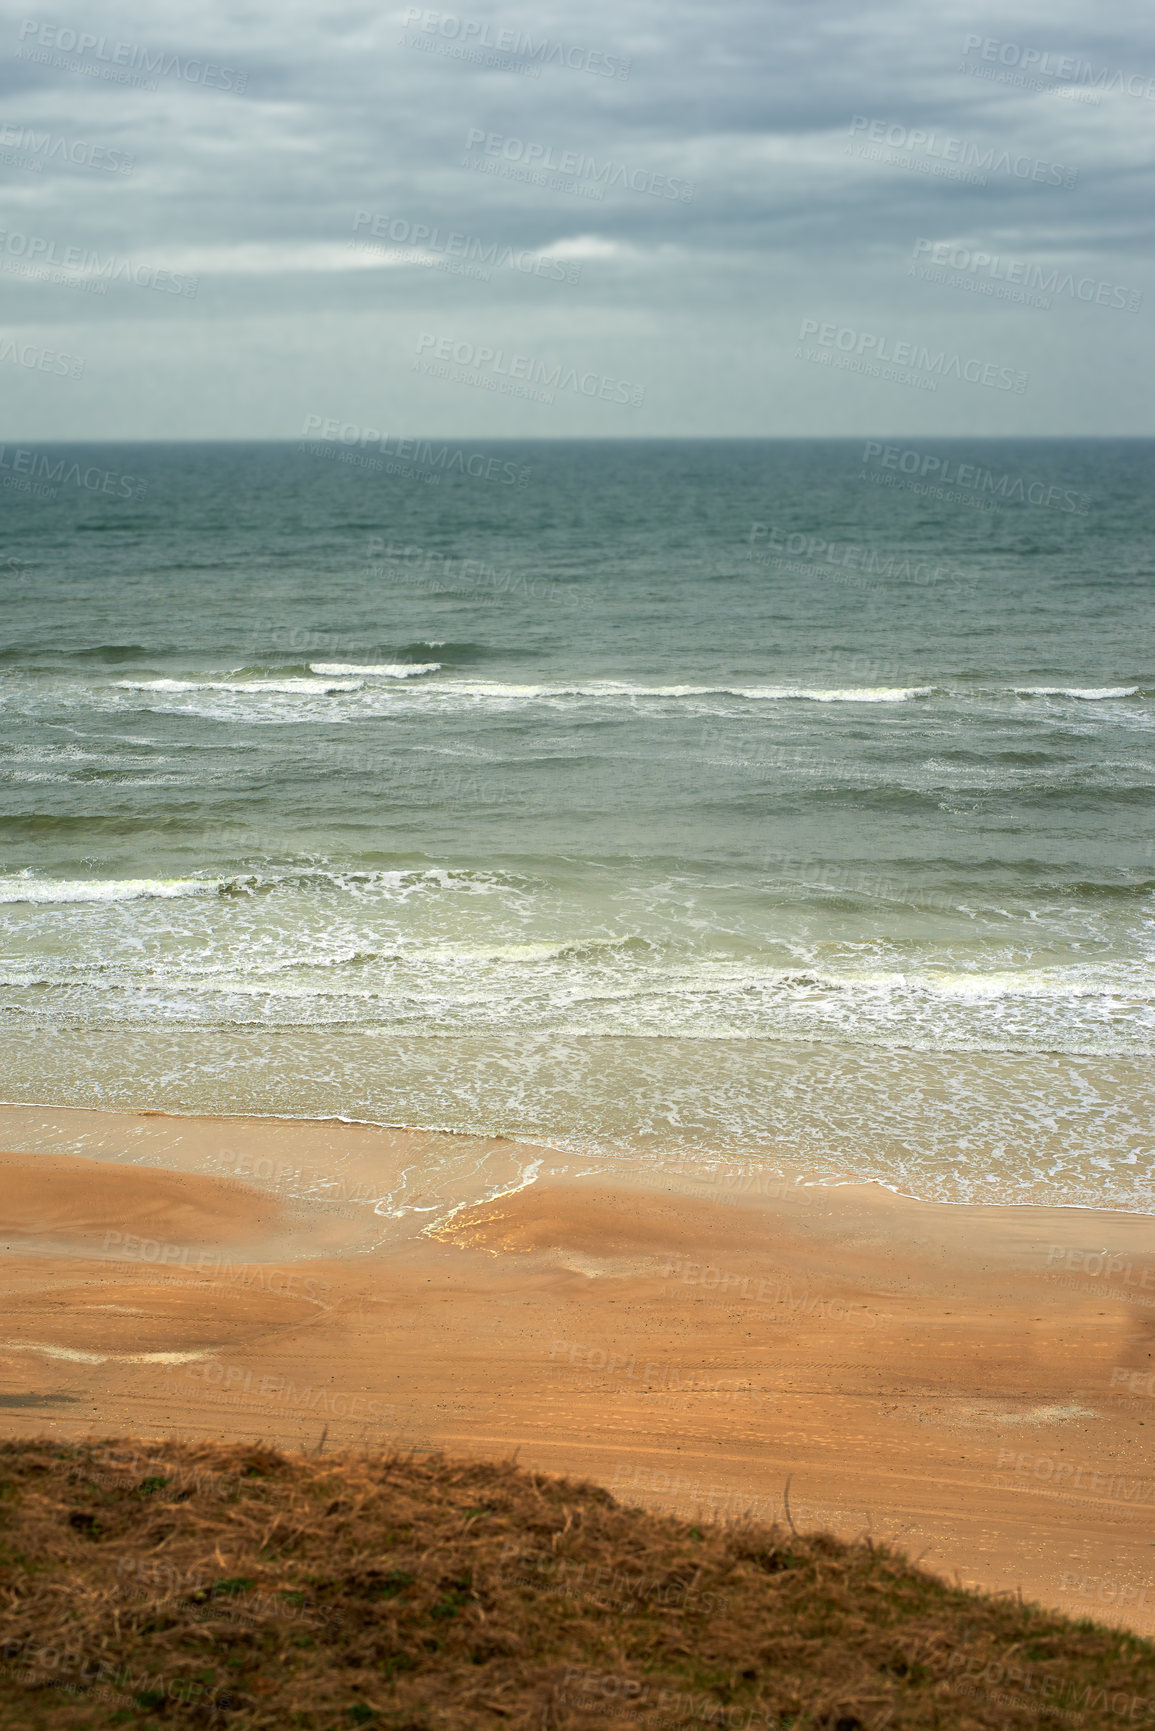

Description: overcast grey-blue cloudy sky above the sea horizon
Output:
[0,0,1155,445]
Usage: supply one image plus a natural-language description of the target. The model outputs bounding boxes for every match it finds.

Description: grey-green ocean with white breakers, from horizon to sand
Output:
[0,439,1155,1212]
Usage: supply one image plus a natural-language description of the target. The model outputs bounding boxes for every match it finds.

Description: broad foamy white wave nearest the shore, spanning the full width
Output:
[0,942,1153,1070]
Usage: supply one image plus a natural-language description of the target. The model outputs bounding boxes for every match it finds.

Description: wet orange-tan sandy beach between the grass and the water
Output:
[0,1106,1155,1634]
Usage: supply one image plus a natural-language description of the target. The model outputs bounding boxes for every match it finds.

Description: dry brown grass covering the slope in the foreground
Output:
[0,1440,1155,1731]
